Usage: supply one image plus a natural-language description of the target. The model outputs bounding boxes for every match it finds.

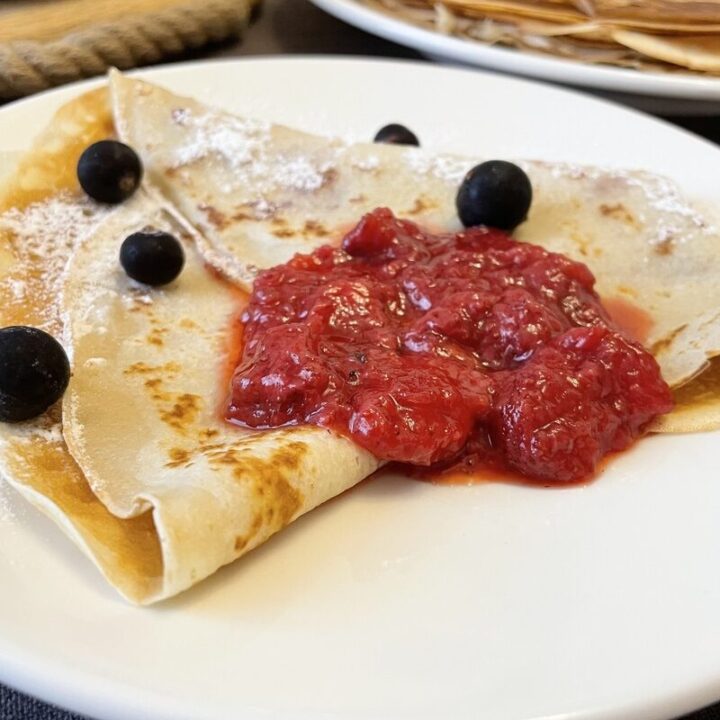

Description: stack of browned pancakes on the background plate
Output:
[371,0,720,74]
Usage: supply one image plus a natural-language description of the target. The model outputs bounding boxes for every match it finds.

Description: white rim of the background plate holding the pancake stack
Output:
[311,0,720,115]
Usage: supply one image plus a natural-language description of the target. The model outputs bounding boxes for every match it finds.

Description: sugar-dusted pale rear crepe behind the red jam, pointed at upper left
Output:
[111,74,720,414]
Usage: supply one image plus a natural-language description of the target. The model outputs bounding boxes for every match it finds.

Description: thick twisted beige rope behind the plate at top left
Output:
[0,0,259,101]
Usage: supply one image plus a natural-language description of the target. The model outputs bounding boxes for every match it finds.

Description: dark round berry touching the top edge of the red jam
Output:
[456,160,532,230]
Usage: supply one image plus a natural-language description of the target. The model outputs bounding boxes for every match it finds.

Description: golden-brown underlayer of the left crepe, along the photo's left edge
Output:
[0,89,162,600]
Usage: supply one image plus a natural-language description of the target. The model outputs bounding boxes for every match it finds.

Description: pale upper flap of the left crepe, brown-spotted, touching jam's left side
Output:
[63,194,378,600]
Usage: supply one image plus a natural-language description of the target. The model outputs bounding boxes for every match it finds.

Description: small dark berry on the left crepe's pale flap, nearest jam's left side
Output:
[120,230,185,285]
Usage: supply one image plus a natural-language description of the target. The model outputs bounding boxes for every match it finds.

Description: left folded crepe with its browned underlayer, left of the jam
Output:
[0,87,378,604]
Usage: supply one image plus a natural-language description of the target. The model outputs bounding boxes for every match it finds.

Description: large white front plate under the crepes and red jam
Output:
[0,58,720,720]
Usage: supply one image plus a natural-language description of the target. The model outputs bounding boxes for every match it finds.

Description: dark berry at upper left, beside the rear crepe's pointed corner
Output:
[77,140,143,205]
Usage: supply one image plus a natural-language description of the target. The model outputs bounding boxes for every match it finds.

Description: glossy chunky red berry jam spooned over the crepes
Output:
[226,209,672,482]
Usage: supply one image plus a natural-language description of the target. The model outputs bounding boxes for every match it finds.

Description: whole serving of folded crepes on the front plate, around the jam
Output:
[0,74,720,603]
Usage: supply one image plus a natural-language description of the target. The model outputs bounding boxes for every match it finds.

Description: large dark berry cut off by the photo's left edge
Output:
[0,325,70,422]
